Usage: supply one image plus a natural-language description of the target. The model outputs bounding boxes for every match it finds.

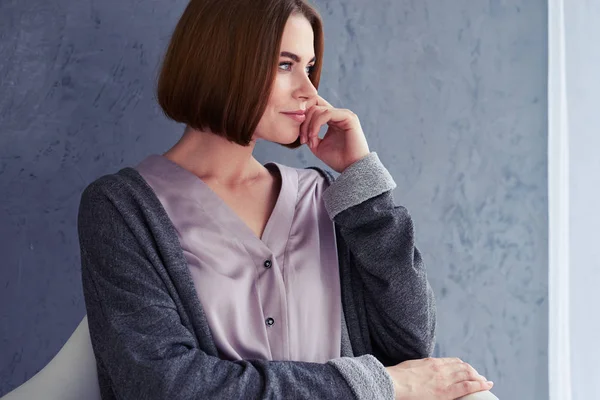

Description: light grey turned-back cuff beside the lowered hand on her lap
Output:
[329,354,394,400]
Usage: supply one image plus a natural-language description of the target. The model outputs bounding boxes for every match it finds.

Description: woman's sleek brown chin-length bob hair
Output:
[157,0,323,149]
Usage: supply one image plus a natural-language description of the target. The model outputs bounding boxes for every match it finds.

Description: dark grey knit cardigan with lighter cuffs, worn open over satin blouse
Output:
[78,152,436,400]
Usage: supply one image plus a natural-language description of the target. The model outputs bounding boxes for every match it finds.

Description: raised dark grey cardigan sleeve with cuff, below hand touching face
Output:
[323,152,436,365]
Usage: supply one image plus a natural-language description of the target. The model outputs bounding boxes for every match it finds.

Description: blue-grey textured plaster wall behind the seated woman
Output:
[0,0,548,400]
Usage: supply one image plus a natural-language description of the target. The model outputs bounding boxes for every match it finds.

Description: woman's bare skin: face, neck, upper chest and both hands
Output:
[164,15,493,400]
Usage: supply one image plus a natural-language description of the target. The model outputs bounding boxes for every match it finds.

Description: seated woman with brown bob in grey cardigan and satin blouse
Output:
[78,0,491,399]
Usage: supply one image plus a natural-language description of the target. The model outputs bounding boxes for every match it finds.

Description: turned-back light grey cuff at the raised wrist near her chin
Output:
[323,152,396,221]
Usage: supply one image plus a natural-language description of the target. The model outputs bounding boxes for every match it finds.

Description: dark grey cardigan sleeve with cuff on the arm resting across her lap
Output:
[78,181,393,400]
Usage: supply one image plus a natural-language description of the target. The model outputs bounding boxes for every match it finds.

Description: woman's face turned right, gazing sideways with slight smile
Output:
[253,15,317,144]
